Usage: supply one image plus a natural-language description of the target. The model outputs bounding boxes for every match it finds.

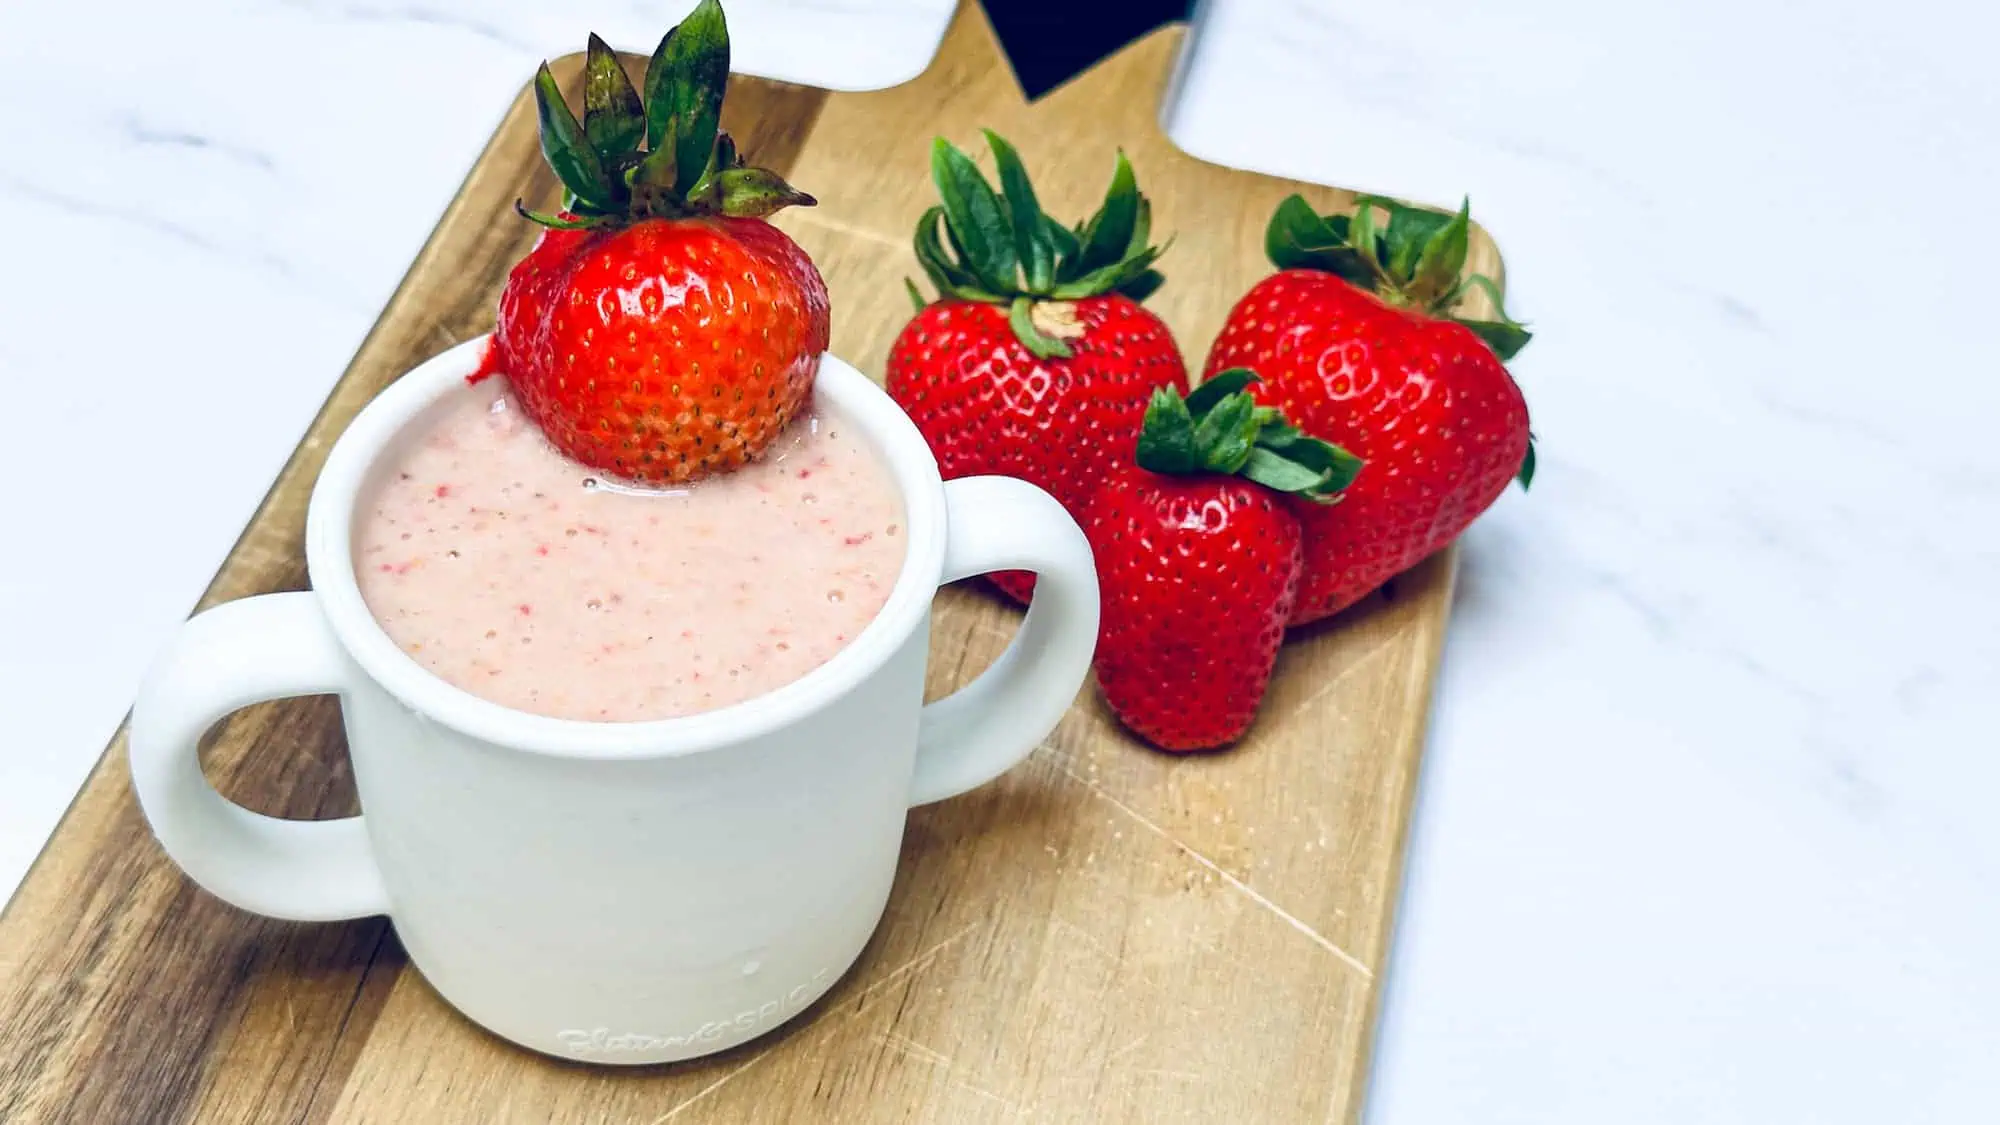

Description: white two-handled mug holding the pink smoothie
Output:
[130,340,1098,1063]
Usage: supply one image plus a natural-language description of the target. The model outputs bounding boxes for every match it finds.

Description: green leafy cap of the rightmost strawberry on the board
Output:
[1264,194,1534,488]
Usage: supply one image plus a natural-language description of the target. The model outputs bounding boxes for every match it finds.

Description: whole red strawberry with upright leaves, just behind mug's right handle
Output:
[886,130,1188,601]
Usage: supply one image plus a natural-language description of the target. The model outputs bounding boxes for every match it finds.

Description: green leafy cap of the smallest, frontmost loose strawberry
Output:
[1138,366,1362,504]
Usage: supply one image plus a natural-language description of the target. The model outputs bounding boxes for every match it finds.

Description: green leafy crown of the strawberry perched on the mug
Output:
[514,0,816,230]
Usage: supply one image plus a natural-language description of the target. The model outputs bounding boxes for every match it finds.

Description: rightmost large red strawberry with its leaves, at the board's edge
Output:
[1206,196,1534,625]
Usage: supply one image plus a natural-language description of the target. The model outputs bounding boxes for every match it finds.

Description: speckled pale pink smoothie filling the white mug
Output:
[354,378,904,723]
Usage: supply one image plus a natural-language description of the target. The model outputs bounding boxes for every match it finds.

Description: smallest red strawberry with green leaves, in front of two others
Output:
[1084,370,1358,751]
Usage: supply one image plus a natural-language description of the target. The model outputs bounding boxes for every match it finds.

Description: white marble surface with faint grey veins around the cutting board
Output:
[0,0,2000,1125]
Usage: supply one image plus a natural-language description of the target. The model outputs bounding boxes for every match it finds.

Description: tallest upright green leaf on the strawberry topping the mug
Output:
[646,0,730,194]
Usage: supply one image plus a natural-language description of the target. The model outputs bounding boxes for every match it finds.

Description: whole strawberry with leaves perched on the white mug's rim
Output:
[474,0,828,484]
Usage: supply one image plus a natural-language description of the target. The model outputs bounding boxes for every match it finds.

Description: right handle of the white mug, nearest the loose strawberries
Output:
[910,476,1098,807]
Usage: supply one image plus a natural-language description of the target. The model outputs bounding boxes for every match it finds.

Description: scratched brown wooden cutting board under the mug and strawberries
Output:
[0,4,1498,1125]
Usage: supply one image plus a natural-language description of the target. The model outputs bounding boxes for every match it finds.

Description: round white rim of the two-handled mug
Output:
[306,334,946,759]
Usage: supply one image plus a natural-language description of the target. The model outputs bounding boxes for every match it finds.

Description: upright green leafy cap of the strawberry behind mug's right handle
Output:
[906,128,1166,358]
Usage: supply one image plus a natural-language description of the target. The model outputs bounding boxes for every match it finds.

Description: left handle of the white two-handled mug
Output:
[128,593,388,923]
